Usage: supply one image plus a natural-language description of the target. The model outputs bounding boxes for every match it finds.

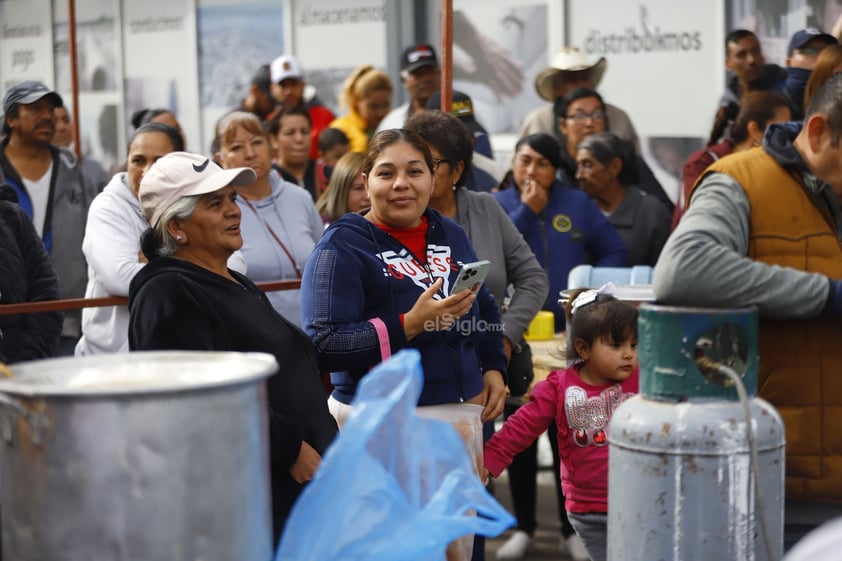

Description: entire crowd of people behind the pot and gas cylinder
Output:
[0,20,842,561]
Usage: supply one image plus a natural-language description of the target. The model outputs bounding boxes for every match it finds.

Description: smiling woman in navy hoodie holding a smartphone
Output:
[301,129,506,425]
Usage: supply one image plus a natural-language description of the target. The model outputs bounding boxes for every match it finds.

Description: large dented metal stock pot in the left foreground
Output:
[0,352,277,561]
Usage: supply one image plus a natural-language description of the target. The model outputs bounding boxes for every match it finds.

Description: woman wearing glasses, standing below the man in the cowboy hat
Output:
[556,88,675,212]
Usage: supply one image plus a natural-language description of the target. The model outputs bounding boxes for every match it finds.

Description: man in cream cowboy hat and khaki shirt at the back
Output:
[520,47,640,153]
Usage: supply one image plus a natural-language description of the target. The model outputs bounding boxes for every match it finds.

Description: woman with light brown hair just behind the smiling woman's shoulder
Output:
[316,152,371,224]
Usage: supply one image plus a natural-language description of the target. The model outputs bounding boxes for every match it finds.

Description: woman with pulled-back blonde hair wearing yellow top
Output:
[330,64,394,153]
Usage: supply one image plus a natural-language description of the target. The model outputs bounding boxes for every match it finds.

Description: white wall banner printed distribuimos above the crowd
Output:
[568,0,725,137]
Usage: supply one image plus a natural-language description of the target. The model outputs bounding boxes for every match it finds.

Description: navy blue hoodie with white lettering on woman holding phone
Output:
[301,209,506,405]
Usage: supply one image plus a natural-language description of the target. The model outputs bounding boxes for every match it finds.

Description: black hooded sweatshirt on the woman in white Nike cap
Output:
[129,257,336,538]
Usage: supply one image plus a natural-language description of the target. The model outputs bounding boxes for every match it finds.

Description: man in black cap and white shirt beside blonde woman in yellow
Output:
[377,43,441,131]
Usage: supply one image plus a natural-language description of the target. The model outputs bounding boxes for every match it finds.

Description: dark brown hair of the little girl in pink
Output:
[565,288,638,360]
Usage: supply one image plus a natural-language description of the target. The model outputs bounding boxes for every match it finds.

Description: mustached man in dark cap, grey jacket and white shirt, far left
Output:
[0,80,97,354]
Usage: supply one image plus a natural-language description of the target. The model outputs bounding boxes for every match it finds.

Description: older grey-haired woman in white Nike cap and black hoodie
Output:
[129,152,336,543]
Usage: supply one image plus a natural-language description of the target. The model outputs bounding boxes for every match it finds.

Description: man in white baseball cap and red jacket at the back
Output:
[266,55,336,160]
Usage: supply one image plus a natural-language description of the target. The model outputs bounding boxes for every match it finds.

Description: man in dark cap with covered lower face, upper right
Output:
[784,27,838,121]
